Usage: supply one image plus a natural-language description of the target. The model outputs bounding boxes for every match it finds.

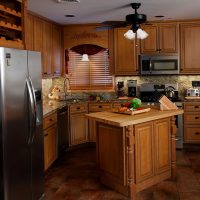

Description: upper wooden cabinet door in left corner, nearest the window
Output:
[52,25,63,76]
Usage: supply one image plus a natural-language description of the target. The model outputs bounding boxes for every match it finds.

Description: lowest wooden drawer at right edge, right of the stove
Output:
[184,126,200,142]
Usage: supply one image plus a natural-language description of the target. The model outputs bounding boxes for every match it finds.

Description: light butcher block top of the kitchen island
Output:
[86,108,183,127]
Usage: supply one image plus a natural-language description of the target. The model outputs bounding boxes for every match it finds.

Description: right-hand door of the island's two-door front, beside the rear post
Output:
[154,118,171,174]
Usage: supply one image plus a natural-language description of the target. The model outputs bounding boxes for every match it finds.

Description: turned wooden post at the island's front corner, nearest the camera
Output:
[125,125,136,200]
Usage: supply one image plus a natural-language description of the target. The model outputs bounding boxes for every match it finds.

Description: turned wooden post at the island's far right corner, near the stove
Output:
[171,116,177,180]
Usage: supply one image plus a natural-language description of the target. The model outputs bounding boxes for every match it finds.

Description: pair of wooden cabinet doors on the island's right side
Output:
[135,118,171,183]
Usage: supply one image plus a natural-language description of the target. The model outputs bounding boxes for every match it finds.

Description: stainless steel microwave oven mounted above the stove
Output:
[140,55,180,75]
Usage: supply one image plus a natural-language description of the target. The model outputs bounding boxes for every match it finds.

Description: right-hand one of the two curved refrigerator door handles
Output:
[26,77,36,144]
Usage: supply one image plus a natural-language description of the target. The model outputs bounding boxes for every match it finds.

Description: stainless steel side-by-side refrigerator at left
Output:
[0,47,44,200]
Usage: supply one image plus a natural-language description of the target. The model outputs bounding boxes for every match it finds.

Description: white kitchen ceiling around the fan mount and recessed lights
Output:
[28,0,200,24]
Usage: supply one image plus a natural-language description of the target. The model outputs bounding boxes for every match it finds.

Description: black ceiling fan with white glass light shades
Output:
[96,3,148,39]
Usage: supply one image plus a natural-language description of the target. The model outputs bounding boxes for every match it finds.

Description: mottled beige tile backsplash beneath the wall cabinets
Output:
[42,75,200,98]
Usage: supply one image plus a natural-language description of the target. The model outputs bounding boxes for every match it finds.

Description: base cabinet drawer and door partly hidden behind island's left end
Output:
[88,102,112,142]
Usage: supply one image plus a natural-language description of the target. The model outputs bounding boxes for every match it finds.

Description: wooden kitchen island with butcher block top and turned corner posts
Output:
[86,108,183,199]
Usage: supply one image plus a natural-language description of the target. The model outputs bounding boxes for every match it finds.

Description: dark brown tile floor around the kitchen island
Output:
[45,145,200,200]
